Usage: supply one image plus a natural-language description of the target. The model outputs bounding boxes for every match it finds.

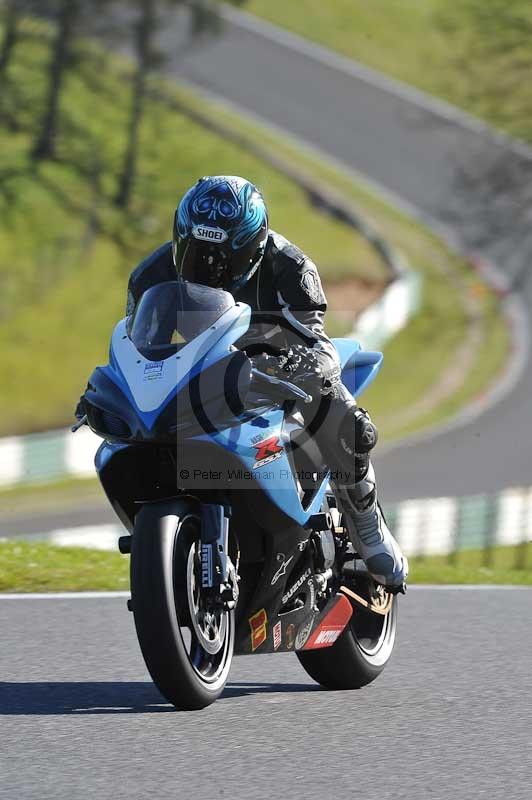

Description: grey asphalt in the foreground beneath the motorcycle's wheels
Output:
[0,588,532,800]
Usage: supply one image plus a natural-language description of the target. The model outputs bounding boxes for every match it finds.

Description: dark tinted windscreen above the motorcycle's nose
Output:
[127,281,235,360]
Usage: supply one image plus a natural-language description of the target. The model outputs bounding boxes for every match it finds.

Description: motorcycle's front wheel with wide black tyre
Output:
[131,498,235,710]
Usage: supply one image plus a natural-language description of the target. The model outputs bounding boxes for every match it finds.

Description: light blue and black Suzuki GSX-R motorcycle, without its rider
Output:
[73,281,397,709]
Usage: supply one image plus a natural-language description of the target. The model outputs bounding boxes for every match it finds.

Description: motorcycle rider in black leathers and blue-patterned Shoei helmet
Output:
[127,175,408,590]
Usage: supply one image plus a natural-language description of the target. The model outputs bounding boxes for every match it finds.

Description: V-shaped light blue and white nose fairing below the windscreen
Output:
[101,303,251,430]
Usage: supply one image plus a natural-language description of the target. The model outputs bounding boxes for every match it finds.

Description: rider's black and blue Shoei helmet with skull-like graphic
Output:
[173,175,268,291]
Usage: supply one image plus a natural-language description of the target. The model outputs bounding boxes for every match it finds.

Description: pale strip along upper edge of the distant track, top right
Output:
[222,6,532,159]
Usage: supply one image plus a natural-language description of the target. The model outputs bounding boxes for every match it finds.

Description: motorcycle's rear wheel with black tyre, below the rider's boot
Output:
[297,597,397,689]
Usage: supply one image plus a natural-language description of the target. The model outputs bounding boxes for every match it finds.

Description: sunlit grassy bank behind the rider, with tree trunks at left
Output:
[0,23,382,434]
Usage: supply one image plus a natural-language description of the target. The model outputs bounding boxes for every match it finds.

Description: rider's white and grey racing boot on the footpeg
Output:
[335,462,408,590]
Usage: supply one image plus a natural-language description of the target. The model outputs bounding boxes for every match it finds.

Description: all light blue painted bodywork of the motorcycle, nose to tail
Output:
[92,294,382,525]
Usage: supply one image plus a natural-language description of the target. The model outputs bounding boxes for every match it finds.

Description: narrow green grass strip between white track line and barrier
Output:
[0,541,532,592]
